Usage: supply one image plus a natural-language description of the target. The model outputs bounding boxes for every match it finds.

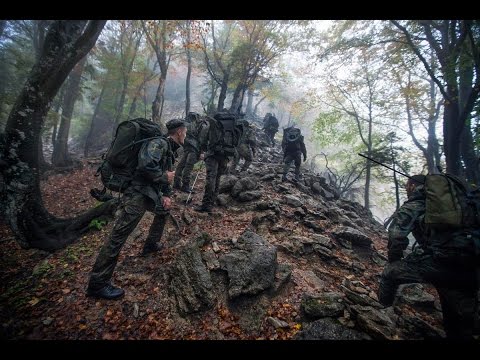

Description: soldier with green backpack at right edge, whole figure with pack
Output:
[378,174,480,339]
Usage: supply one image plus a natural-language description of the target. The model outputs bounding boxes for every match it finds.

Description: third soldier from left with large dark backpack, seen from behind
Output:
[194,112,243,213]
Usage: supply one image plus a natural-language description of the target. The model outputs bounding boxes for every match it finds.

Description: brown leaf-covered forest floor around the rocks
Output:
[0,160,438,340]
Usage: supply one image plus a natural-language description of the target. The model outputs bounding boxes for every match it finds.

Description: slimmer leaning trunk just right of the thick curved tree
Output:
[52,56,87,167]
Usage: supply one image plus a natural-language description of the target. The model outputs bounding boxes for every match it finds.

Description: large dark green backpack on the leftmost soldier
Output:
[94,118,163,197]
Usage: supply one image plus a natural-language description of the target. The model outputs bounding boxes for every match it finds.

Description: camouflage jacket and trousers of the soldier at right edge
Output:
[378,186,478,338]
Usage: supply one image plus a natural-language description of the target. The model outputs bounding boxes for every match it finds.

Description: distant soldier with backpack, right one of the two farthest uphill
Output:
[282,126,307,181]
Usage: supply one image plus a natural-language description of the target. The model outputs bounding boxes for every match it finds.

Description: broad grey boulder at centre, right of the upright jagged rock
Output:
[219,230,277,299]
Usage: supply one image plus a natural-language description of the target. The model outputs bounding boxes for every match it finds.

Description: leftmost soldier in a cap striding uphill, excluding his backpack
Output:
[87,119,187,300]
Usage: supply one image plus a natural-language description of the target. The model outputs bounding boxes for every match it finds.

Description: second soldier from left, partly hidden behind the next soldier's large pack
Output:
[173,112,209,193]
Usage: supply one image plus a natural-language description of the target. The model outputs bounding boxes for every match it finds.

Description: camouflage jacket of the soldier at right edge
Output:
[388,186,426,262]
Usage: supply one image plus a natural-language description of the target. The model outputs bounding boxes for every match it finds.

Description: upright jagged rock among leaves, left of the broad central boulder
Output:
[169,243,215,315]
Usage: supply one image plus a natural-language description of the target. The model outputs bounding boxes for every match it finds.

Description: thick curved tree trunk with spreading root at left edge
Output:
[1,20,109,251]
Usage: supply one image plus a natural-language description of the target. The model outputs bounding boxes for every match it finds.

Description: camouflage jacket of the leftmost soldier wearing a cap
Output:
[130,137,179,206]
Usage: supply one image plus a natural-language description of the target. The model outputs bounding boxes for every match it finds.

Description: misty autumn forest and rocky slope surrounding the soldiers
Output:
[0,20,480,340]
